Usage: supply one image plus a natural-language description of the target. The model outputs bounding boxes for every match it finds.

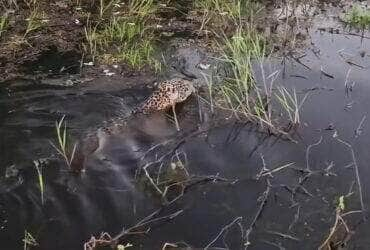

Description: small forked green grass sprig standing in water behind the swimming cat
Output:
[50,116,77,167]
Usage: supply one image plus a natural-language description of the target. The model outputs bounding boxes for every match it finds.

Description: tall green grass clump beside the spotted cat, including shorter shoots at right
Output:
[207,27,308,134]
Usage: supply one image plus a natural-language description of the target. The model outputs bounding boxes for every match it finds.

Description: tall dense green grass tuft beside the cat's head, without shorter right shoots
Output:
[212,29,272,126]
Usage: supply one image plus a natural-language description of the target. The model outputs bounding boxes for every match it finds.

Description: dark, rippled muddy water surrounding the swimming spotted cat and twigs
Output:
[0,22,370,250]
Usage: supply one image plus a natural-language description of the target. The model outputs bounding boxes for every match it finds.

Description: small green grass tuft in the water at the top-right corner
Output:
[345,5,370,29]
